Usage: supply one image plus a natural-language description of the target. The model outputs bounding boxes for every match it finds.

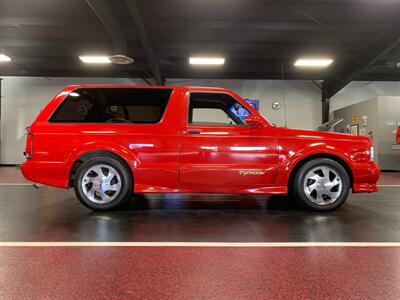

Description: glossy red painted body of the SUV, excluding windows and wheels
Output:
[21,85,380,194]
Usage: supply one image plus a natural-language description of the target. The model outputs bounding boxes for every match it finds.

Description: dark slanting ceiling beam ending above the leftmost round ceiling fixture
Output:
[86,0,127,55]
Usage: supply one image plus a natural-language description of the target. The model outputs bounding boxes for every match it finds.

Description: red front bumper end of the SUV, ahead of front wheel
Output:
[353,162,381,193]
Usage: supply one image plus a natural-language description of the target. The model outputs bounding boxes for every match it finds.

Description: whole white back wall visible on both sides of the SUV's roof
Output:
[0,77,321,164]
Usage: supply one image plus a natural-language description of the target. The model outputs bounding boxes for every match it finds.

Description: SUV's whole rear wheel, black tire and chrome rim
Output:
[74,156,132,210]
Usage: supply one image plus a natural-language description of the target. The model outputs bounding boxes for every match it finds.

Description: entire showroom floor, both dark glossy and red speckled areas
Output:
[0,168,400,299]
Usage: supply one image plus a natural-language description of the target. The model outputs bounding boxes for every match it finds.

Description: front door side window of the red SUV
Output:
[188,93,249,126]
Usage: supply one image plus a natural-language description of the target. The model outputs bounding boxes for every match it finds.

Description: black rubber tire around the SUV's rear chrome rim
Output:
[74,156,133,210]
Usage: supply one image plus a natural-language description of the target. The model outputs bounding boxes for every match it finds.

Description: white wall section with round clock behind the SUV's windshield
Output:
[167,79,322,129]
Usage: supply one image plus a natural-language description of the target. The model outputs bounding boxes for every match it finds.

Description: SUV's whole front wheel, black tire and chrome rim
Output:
[290,158,350,211]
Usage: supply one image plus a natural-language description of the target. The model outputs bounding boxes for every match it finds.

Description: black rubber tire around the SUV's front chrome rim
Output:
[289,158,350,212]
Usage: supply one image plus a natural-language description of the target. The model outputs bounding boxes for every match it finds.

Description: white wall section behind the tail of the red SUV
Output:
[0,77,147,164]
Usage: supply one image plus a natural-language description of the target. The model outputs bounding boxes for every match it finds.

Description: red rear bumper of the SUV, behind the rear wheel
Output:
[20,160,69,188]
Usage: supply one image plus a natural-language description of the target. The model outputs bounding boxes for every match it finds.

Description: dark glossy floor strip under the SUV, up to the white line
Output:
[0,185,400,242]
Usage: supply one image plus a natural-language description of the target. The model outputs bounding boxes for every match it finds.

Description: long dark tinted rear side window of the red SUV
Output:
[50,88,172,123]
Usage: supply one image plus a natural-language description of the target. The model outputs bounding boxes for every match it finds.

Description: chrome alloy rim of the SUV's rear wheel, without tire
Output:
[82,164,121,204]
